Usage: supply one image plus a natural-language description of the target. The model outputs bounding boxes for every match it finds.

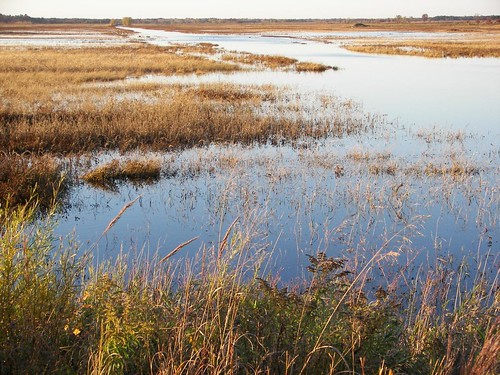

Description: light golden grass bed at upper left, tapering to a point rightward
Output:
[0,44,239,91]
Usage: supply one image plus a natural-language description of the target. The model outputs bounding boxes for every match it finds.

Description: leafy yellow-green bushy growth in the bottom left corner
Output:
[0,205,85,374]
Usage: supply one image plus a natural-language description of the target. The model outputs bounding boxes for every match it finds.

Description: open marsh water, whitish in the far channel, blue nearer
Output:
[52,29,500,280]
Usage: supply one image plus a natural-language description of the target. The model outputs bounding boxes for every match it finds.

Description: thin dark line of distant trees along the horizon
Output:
[0,14,500,25]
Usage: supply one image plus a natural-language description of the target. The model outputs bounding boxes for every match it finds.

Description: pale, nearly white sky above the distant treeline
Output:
[0,0,500,18]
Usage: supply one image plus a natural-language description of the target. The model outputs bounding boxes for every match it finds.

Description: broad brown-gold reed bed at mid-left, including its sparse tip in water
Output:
[0,80,379,154]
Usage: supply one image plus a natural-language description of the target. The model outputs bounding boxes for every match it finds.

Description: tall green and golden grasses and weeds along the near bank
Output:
[0,207,500,375]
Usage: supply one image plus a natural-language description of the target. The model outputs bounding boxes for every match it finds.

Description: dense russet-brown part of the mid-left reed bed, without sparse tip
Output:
[0,93,312,153]
